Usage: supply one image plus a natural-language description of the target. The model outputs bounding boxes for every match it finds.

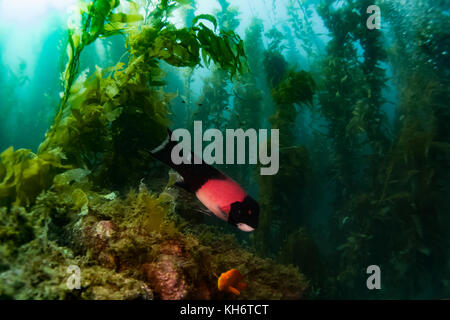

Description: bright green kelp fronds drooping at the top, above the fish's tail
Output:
[126,1,246,76]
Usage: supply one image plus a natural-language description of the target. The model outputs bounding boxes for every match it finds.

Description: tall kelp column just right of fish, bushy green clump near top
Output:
[255,33,315,262]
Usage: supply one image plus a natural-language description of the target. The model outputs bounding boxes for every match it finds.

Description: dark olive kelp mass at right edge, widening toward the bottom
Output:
[339,72,450,297]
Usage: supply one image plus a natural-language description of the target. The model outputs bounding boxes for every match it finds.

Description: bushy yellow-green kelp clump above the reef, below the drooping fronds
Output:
[39,59,169,169]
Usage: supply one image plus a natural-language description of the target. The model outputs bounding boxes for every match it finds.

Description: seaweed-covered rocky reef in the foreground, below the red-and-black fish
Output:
[0,169,308,300]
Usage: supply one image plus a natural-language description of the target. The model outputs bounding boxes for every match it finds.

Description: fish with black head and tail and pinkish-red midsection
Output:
[146,130,259,232]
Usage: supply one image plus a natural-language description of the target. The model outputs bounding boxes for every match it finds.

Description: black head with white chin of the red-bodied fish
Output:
[228,195,259,232]
